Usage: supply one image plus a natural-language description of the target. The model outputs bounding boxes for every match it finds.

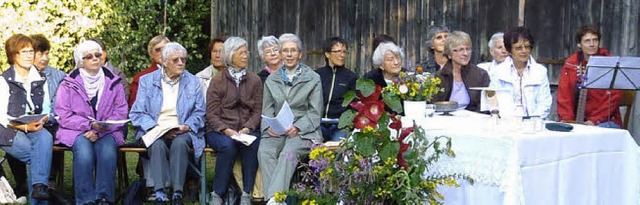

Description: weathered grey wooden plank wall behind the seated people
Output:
[211,0,640,83]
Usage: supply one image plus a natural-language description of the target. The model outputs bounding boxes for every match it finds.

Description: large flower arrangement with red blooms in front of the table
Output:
[287,79,468,204]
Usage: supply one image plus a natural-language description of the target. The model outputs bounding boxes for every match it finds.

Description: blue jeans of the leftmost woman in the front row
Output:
[2,129,53,204]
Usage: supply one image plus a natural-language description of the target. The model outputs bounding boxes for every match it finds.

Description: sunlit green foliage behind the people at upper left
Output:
[0,0,211,76]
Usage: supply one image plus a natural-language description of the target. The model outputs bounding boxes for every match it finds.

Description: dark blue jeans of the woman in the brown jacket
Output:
[205,131,260,196]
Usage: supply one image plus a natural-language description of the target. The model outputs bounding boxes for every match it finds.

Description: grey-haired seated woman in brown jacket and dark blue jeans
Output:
[206,37,262,205]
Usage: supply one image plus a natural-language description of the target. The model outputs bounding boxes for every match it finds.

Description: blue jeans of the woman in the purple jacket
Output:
[72,134,118,204]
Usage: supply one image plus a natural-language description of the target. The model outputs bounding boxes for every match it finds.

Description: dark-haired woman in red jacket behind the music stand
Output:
[557,25,622,128]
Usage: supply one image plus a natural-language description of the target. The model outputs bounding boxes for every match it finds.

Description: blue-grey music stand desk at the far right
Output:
[584,56,640,90]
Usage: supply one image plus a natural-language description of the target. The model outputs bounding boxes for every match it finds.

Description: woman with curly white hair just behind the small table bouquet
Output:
[363,42,404,88]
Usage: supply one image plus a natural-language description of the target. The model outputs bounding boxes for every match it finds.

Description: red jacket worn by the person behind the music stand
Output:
[557,48,622,125]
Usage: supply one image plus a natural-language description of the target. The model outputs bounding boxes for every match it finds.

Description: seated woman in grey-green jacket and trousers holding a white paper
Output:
[258,33,322,202]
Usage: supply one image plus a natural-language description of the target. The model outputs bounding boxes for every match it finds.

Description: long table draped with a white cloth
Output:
[403,110,640,205]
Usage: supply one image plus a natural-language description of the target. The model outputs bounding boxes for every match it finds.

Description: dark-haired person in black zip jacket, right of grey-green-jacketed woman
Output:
[316,37,358,141]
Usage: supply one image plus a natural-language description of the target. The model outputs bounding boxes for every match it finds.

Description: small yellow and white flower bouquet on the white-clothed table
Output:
[384,66,442,101]
